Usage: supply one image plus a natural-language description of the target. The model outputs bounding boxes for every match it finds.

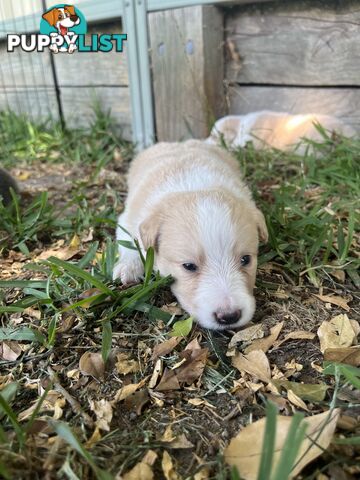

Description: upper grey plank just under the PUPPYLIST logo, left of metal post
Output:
[54,21,129,86]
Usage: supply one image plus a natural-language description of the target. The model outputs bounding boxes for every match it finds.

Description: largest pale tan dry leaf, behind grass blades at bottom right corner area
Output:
[224,409,340,480]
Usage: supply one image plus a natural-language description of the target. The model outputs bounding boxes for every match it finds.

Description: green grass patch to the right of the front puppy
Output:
[236,133,360,287]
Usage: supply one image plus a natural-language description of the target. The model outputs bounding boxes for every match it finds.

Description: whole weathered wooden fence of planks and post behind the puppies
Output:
[0,0,360,140]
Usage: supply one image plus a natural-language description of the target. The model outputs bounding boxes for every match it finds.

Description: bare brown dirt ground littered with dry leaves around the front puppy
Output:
[0,155,360,480]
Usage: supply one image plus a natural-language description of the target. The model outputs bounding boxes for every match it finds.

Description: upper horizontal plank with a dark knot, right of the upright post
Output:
[225,0,360,86]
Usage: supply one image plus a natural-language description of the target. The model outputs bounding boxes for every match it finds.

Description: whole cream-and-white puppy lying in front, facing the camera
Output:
[113,140,268,330]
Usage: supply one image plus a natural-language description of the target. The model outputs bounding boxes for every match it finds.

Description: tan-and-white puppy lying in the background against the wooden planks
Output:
[206,111,355,155]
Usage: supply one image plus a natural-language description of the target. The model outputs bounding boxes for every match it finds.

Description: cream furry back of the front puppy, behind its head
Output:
[127,140,250,216]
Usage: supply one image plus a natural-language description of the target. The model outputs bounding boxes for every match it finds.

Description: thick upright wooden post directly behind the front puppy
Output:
[148,7,224,141]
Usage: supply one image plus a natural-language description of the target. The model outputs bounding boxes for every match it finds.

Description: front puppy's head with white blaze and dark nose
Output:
[140,191,267,330]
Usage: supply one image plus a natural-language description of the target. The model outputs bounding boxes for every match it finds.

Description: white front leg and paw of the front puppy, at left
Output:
[113,213,144,285]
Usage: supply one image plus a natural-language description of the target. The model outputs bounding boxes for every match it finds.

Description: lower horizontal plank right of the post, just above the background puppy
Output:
[229,86,360,133]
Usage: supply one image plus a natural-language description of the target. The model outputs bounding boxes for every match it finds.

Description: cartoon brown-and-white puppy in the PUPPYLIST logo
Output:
[42,5,80,53]
